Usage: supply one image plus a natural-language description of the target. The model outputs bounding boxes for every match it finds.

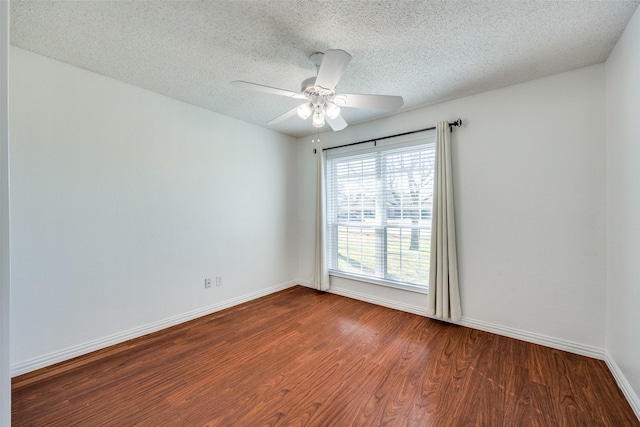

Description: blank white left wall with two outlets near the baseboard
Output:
[10,47,297,374]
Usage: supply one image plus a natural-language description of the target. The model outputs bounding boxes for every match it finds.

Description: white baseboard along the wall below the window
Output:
[310,280,604,360]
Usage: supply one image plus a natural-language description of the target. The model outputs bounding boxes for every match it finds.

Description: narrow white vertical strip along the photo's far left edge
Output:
[0,1,11,427]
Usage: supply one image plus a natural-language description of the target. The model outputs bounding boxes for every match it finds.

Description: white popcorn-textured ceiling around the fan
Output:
[10,0,638,136]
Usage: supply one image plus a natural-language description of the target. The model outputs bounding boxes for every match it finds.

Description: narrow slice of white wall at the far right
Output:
[606,5,640,418]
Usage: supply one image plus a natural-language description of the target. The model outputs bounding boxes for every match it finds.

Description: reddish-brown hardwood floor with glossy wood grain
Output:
[12,286,640,426]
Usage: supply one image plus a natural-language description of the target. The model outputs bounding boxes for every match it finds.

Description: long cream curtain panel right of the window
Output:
[427,121,462,322]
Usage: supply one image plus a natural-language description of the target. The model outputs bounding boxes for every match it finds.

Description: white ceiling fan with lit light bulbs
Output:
[231,49,404,131]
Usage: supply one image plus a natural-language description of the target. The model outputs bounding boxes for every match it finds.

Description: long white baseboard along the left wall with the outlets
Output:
[11,280,298,377]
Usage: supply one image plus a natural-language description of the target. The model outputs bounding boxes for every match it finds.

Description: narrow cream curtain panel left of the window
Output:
[313,148,329,291]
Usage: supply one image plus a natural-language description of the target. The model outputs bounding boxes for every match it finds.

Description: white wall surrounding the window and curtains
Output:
[298,65,605,356]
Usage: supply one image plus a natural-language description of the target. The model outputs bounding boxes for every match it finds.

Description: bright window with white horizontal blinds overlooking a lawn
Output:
[327,139,435,291]
